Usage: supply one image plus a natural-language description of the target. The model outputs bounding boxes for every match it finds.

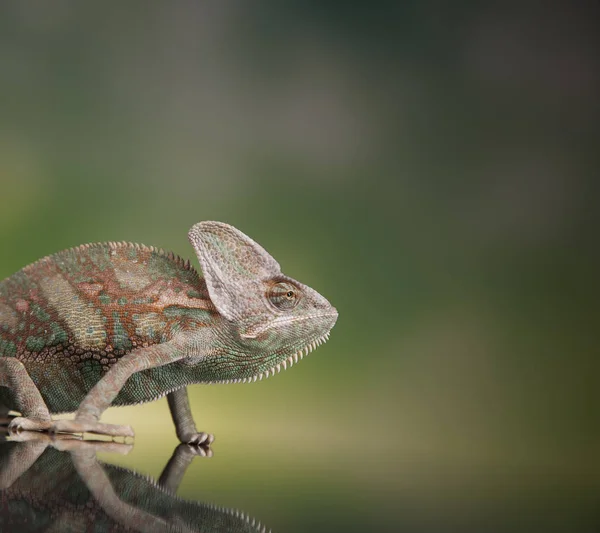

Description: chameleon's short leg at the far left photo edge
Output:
[0,357,52,432]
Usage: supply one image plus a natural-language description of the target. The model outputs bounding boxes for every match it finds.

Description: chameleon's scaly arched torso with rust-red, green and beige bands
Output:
[0,243,218,412]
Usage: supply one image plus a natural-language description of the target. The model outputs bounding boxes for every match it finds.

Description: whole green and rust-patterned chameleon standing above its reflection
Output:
[0,222,338,444]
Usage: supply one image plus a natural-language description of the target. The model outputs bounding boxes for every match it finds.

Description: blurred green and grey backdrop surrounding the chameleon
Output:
[0,0,600,532]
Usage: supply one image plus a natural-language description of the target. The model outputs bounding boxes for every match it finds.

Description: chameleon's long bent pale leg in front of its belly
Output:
[50,338,191,437]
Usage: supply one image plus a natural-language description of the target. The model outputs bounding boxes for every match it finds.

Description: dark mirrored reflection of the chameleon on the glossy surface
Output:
[0,433,268,533]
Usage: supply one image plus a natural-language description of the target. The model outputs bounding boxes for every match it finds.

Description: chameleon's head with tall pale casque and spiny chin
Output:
[189,222,338,381]
